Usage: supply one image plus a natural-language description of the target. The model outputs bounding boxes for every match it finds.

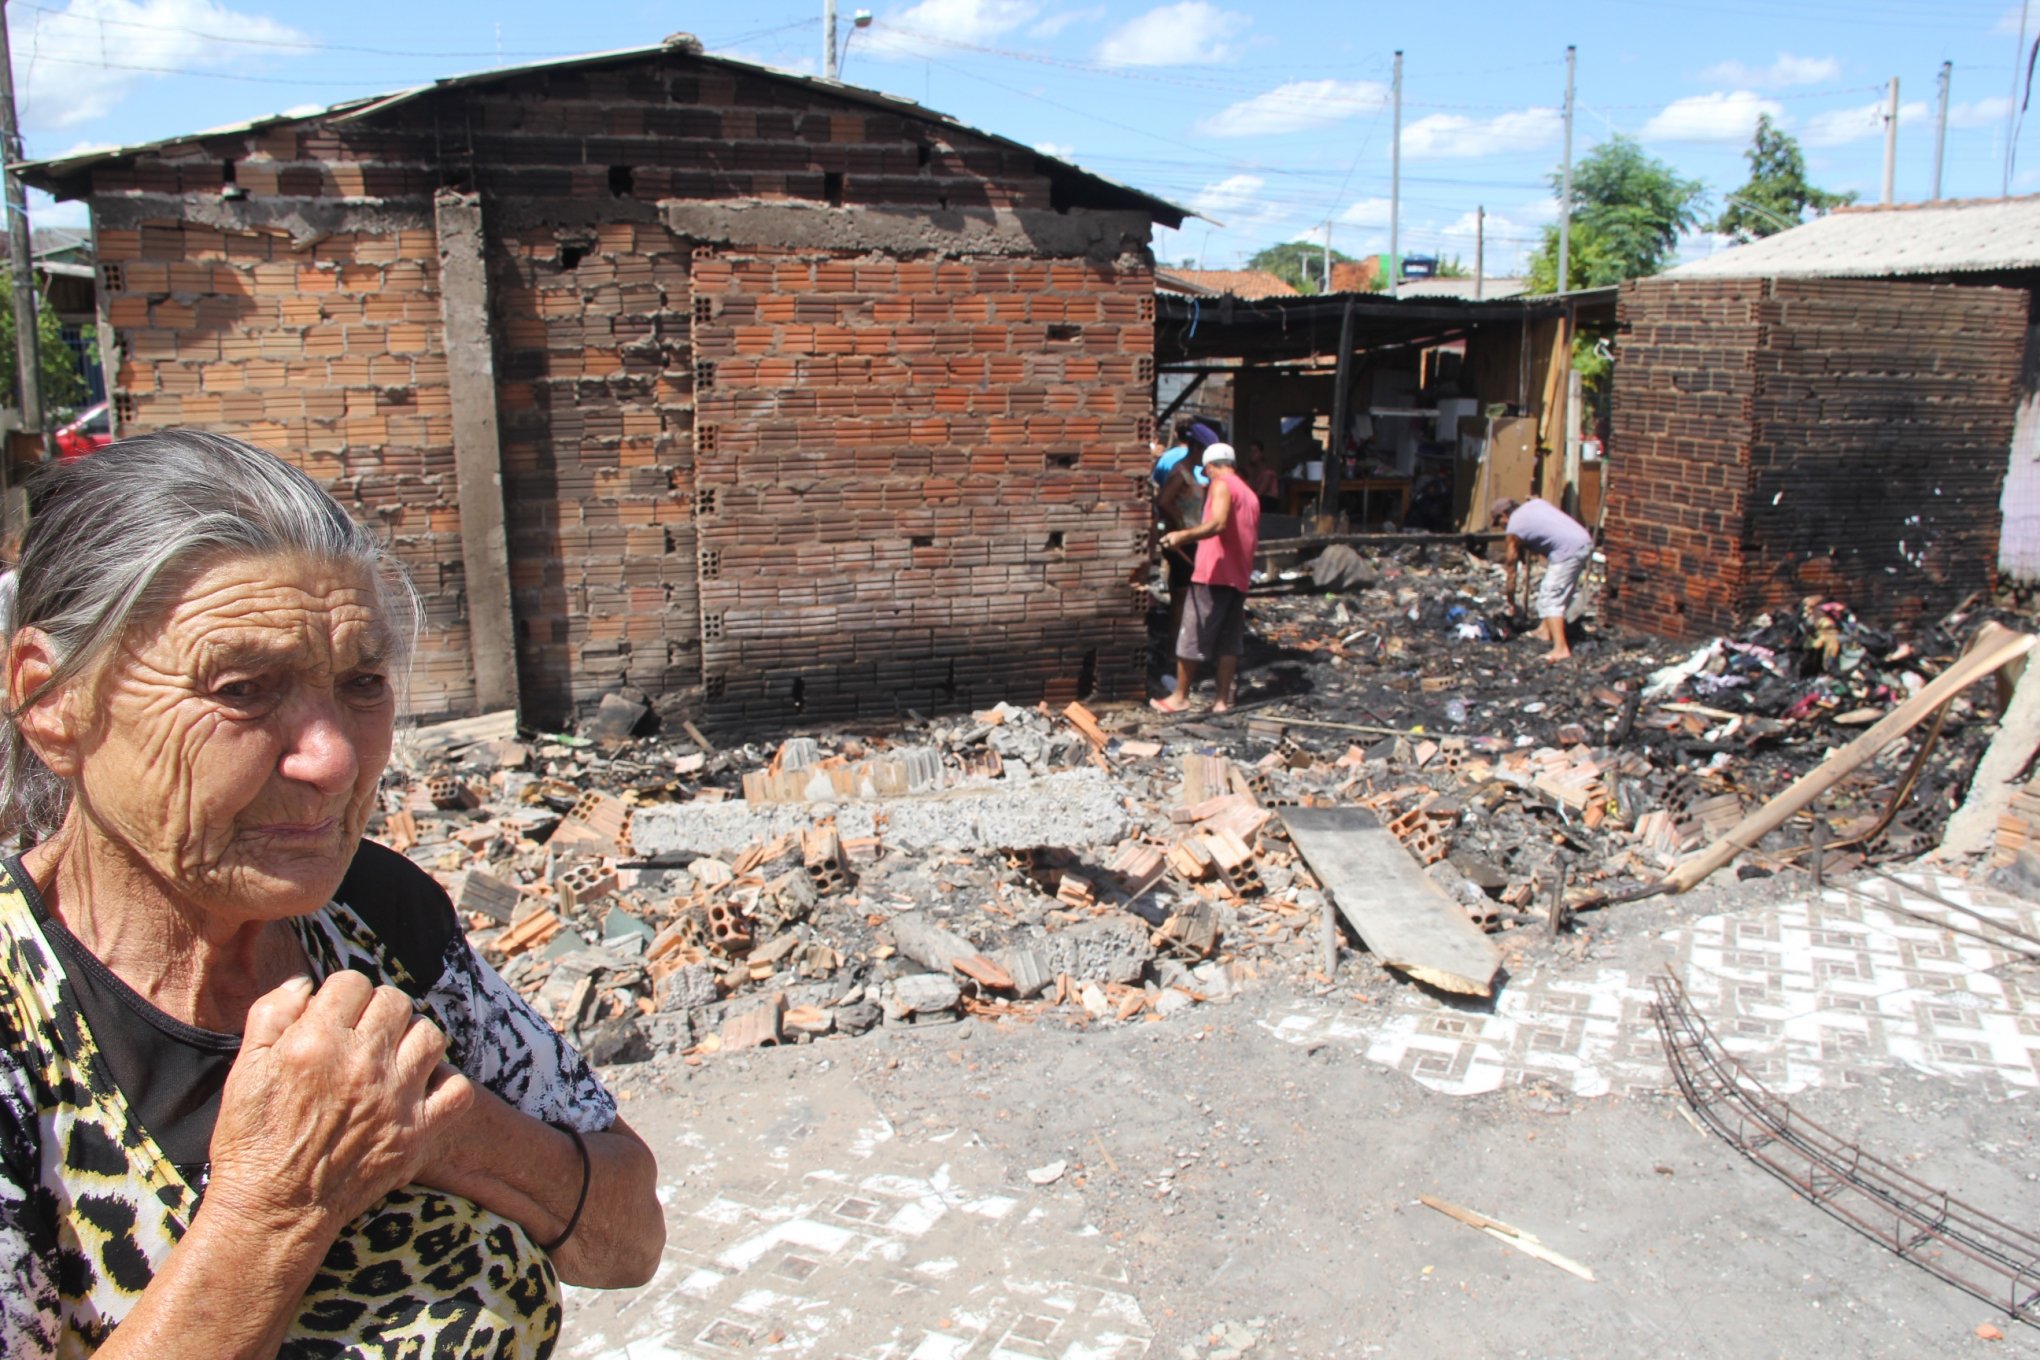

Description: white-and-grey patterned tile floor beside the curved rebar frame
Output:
[1263,873,2040,1095]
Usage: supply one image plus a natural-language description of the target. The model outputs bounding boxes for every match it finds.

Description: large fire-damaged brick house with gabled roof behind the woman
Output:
[24,39,1183,726]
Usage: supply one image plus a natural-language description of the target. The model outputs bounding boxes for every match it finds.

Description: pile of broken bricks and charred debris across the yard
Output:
[371,559,2023,1062]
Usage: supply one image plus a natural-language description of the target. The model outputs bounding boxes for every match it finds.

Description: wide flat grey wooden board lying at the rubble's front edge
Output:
[1281,807,1501,997]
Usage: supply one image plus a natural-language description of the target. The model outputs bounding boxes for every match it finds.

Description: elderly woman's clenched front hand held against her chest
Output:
[202,973,475,1234]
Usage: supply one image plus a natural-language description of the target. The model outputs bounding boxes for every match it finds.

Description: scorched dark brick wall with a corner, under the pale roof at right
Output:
[1608,279,2026,636]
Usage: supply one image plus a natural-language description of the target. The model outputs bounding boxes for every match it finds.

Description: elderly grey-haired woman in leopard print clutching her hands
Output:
[0,430,665,1360]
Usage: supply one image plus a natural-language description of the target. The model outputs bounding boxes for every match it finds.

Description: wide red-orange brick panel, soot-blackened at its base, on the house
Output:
[694,253,1155,724]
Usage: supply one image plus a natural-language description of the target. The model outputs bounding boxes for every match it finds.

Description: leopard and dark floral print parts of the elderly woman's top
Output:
[0,867,616,1360]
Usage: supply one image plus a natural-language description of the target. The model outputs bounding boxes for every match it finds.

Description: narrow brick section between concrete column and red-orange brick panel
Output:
[490,222,702,714]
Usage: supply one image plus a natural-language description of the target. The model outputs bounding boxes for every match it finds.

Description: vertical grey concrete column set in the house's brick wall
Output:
[432,190,518,714]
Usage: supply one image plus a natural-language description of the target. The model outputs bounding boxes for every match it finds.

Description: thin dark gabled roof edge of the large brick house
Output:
[14,33,1197,226]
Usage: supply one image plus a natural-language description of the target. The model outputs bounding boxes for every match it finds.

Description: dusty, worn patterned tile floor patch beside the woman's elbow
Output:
[561,1068,1153,1360]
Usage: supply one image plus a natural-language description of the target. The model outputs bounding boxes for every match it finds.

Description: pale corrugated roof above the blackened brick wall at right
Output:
[1665,196,2040,279]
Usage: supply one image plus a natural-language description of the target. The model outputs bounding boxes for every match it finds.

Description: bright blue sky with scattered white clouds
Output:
[6,0,2040,275]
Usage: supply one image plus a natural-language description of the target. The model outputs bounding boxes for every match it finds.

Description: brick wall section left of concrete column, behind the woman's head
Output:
[98,215,473,714]
